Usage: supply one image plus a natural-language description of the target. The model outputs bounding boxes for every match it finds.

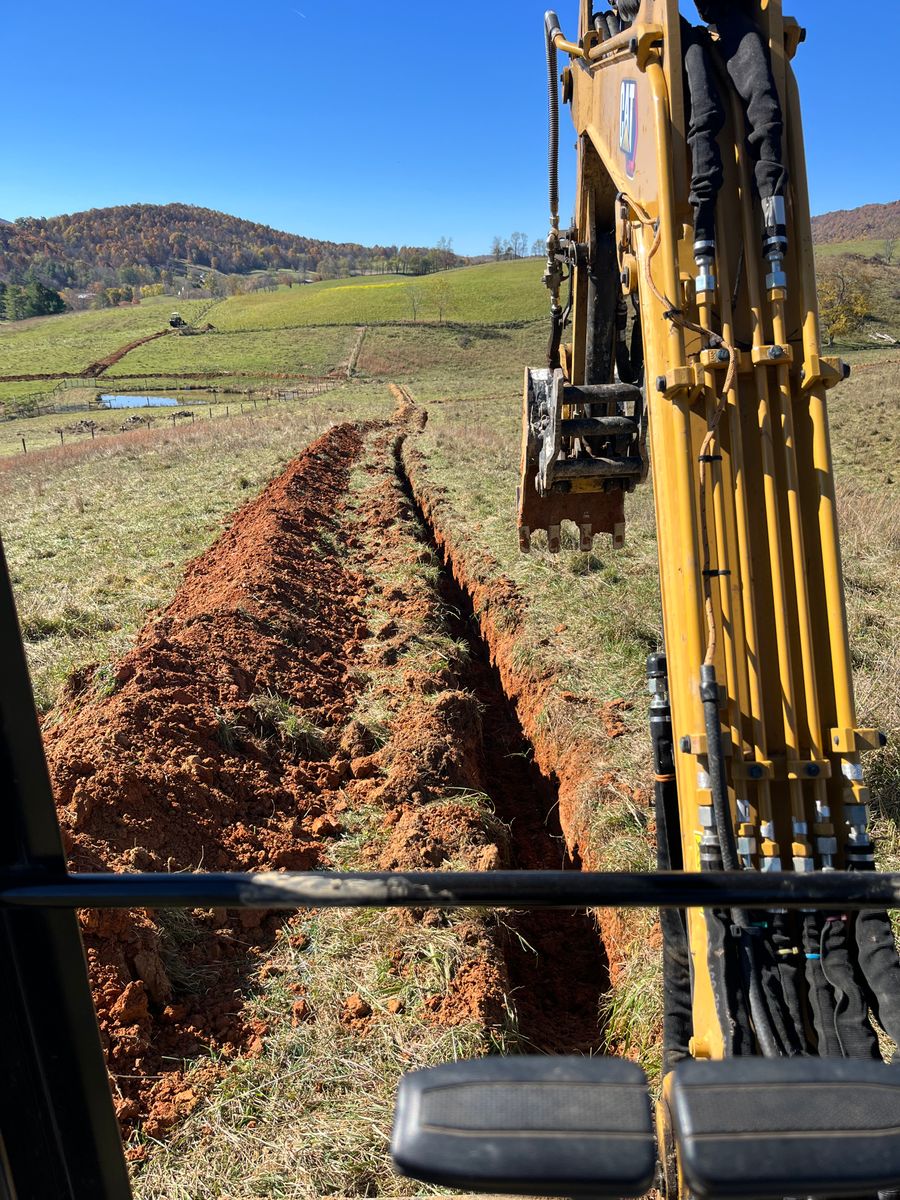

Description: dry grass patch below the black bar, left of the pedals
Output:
[134,907,501,1200]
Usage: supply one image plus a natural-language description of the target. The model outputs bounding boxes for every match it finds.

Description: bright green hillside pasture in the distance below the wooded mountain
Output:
[0,259,546,417]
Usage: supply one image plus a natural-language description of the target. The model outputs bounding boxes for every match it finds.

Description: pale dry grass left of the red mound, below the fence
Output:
[0,388,388,712]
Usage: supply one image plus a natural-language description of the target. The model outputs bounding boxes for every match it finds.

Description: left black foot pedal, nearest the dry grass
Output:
[391,1056,656,1196]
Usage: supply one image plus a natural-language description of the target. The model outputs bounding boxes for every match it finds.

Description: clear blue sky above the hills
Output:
[0,0,900,253]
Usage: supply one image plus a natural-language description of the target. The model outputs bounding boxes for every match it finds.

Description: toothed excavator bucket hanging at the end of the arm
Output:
[518,368,646,553]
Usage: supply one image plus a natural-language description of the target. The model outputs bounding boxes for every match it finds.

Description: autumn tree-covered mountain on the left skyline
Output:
[0,204,462,288]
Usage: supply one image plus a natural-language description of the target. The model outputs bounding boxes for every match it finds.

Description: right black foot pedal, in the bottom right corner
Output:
[667,1058,900,1198]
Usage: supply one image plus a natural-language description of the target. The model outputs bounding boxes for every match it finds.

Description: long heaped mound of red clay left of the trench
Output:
[46,426,374,1135]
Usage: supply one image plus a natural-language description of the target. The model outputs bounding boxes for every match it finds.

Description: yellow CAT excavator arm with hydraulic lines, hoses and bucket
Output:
[518,0,900,1194]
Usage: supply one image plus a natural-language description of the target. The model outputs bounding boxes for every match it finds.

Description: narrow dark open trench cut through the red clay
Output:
[395,446,610,1054]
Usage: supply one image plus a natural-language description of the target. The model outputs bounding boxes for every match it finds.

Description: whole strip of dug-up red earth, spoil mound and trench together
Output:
[46,392,608,1136]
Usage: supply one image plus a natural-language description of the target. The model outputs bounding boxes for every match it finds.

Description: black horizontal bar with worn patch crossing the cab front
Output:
[0,871,900,911]
